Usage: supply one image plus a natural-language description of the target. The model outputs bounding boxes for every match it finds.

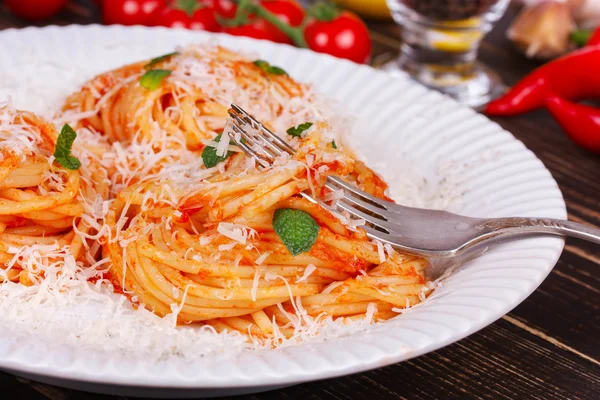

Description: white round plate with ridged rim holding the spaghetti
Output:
[0,26,566,397]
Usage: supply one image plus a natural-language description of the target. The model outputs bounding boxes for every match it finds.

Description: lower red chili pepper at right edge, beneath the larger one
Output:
[546,96,600,154]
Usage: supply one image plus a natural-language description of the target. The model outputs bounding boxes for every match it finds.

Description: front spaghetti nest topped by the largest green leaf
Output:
[105,133,427,336]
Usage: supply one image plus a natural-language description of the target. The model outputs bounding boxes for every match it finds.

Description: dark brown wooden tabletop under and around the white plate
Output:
[0,0,600,400]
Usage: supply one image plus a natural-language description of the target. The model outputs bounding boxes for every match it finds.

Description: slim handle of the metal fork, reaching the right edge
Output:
[484,218,600,244]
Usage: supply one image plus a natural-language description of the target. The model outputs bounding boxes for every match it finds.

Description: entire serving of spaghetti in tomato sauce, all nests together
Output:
[0,46,430,340]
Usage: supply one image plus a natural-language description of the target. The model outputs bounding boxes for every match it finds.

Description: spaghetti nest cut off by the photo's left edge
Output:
[0,105,106,285]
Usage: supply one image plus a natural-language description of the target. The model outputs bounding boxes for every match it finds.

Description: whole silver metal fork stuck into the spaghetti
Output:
[229,104,600,258]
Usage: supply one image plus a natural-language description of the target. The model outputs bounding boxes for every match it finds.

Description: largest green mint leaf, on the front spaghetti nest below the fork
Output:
[273,208,321,256]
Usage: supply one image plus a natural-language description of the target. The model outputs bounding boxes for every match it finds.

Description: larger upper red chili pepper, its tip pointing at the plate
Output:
[485,46,600,116]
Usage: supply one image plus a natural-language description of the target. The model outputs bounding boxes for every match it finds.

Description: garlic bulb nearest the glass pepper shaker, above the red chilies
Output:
[507,0,576,59]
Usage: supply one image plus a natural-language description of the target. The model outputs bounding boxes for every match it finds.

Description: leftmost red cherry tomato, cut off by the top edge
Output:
[102,0,166,25]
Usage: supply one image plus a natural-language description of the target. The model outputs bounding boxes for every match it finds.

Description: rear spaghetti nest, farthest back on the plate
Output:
[65,46,312,150]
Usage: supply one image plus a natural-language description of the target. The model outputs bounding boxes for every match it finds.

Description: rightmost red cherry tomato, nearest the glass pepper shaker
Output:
[304,11,371,63]
